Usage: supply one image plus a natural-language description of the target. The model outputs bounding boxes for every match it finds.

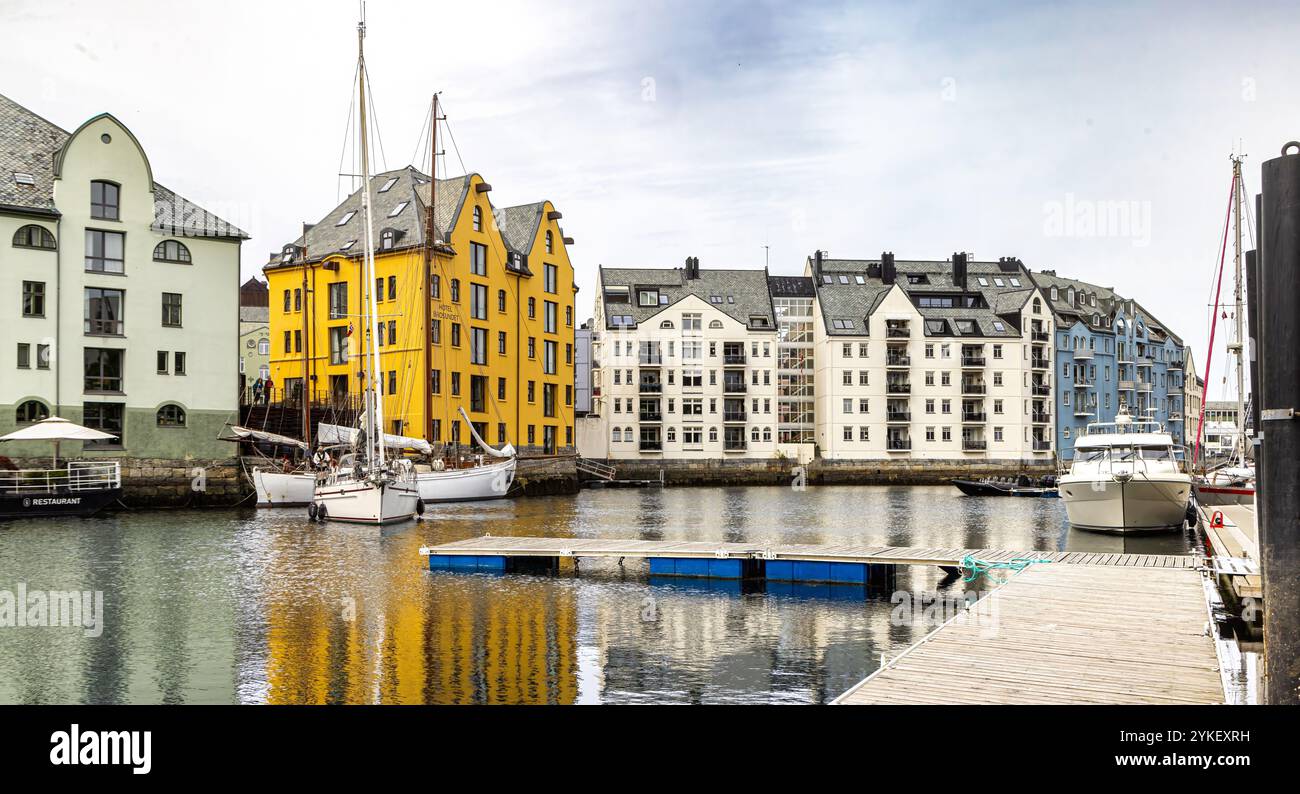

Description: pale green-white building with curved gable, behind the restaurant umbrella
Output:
[0,96,247,460]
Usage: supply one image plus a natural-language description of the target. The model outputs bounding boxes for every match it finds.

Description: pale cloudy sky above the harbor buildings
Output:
[0,0,1300,399]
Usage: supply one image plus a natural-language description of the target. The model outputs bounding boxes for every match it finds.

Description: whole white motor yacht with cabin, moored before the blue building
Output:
[1057,411,1192,533]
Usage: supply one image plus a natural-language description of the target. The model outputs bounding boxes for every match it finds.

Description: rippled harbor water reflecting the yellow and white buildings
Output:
[0,486,1200,703]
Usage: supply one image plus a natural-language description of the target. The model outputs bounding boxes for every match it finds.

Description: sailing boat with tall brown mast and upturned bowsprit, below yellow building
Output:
[416,94,516,503]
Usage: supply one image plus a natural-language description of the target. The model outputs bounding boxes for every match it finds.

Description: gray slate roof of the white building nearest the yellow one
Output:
[599,266,776,330]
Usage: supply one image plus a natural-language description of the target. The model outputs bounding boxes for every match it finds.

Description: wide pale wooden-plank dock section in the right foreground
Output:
[835,565,1226,704]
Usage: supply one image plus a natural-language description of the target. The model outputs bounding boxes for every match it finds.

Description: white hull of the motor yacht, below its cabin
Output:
[1058,476,1192,533]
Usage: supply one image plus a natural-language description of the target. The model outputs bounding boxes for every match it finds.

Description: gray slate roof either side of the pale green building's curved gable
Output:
[0,94,248,239]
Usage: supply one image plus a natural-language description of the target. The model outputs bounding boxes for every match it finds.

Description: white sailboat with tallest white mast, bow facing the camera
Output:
[308,10,424,525]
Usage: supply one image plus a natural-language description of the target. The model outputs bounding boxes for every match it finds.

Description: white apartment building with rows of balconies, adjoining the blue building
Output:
[806,252,1053,465]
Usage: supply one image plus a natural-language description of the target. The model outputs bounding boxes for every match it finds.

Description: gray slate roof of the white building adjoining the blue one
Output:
[814,259,1034,338]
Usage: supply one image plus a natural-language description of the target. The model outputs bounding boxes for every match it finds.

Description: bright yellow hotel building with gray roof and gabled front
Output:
[264,168,577,455]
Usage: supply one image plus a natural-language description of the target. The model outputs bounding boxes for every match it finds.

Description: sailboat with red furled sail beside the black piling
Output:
[1193,156,1255,507]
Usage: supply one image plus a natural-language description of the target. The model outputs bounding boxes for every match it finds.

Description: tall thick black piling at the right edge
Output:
[1256,143,1300,706]
